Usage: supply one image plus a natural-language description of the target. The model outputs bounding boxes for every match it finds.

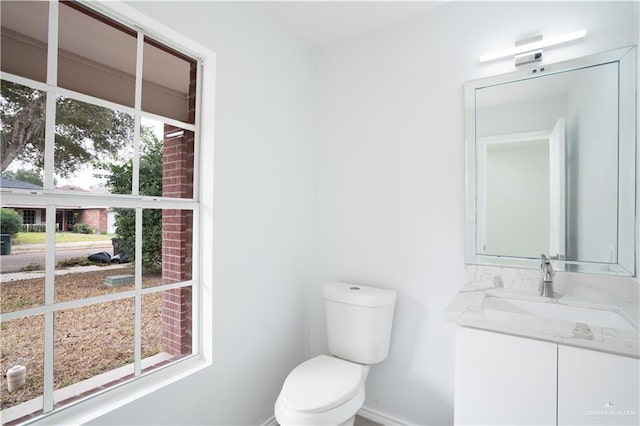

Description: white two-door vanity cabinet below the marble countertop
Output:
[454,327,640,426]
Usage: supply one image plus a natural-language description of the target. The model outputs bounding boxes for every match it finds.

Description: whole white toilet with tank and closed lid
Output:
[275,281,397,426]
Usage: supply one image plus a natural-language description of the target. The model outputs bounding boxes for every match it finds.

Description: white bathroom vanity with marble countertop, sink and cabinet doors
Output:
[446,282,640,425]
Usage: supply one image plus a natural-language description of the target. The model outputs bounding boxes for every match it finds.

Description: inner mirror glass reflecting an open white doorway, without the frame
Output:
[476,63,618,263]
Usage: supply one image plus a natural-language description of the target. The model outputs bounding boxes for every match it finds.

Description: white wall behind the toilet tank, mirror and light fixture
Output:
[311,2,638,424]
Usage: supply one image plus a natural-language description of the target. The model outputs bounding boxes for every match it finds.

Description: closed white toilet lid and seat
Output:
[279,355,369,413]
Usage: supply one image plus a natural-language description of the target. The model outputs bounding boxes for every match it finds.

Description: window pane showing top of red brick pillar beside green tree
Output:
[140,119,194,198]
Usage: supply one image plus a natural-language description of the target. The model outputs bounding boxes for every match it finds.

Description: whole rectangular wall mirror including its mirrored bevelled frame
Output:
[465,47,637,276]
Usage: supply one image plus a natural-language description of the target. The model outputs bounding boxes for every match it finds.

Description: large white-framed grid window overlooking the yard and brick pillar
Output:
[0,1,213,424]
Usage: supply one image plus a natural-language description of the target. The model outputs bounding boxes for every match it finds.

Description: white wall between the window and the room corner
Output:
[89,2,313,425]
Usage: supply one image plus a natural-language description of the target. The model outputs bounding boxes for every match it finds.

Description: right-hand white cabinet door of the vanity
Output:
[558,346,640,425]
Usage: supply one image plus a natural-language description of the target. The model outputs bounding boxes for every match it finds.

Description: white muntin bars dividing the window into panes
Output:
[0,1,201,420]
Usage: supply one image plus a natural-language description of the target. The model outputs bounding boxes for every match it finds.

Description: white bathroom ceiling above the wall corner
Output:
[262,1,444,46]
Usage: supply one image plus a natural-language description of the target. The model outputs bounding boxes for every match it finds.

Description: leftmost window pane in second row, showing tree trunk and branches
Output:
[0,82,46,184]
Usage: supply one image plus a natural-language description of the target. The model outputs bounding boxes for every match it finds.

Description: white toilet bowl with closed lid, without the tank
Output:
[275,355,369,426]
